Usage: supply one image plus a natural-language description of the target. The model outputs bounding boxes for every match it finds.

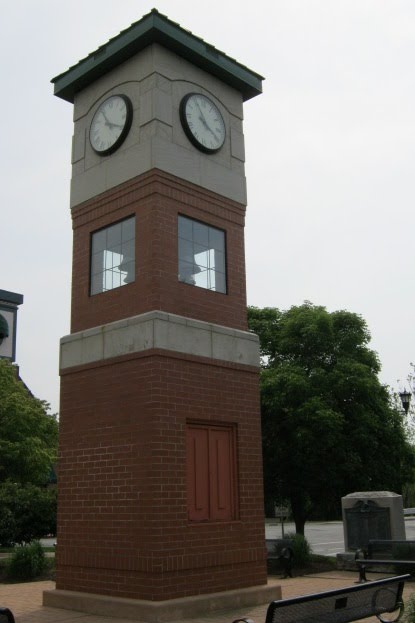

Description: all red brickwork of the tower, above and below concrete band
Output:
[56,170,266,600]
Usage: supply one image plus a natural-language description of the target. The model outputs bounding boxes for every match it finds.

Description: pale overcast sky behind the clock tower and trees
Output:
[0,0,415,411]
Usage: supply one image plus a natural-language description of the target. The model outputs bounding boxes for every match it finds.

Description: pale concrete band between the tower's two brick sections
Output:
[60,311,259,370]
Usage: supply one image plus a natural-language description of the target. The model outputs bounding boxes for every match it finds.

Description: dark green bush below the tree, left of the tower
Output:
[0,482,56,546]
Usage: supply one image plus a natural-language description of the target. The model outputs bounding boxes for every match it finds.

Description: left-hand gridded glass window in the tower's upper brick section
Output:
[91,217,135,294]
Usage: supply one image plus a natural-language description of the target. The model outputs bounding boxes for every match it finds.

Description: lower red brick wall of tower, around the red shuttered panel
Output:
[57,352,266,600]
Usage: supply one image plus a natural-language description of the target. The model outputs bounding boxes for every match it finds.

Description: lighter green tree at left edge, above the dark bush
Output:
[0,359,58,485]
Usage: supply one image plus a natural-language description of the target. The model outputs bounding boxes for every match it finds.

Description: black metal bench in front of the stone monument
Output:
[355,539,415,583]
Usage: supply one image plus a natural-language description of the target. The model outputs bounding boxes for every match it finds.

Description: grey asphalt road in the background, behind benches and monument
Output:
[265,517,415,556]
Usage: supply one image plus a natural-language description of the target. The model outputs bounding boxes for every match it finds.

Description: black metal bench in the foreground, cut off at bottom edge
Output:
[233,575,411,623]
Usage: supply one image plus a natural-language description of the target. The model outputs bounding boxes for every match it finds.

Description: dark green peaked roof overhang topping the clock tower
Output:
[52,9,264,103]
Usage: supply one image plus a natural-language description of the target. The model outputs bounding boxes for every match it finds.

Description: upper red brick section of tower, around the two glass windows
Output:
[71,170,247,333]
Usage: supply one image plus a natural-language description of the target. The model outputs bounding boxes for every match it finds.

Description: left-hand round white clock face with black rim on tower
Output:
[89,95,133,156]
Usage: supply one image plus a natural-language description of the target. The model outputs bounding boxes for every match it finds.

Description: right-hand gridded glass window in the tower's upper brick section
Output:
[178,216,226,293]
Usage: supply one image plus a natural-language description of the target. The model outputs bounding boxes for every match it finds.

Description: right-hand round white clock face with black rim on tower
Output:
[180,93,226,153]
